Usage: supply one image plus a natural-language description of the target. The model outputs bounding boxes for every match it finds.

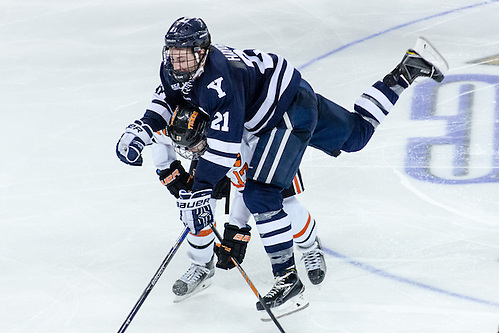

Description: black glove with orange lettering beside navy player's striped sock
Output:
[215,223,251,269]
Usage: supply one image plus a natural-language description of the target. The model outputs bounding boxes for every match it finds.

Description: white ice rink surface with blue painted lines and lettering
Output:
[0,0,499,333]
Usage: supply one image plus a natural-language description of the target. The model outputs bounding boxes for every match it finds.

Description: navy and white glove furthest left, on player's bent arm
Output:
[116,120,152,166]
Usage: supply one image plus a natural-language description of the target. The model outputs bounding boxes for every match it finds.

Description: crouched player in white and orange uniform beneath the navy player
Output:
[152,101,326,306]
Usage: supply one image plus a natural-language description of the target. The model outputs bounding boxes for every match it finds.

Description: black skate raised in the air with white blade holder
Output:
[383,37,449,87]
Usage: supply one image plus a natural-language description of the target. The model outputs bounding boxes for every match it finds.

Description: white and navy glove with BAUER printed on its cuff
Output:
[177,189,213,235]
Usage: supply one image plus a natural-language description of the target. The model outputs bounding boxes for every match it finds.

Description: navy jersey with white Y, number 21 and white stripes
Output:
[160,45,301,191]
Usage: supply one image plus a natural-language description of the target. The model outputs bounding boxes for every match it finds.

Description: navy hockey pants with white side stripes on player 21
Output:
[248,79,374,197]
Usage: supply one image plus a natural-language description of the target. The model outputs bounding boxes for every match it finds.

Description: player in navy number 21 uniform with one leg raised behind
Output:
[117,17,446,316]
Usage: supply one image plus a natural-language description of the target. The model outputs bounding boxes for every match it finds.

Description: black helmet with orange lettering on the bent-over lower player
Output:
[168,103,209,160]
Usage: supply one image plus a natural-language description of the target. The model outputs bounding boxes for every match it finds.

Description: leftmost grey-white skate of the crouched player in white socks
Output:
[172,260,215,302]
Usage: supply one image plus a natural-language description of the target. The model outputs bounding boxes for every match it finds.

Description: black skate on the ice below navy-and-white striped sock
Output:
[256,266,309,321]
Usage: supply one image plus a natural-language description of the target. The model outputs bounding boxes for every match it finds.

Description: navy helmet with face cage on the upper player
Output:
[163,17,211,83]
